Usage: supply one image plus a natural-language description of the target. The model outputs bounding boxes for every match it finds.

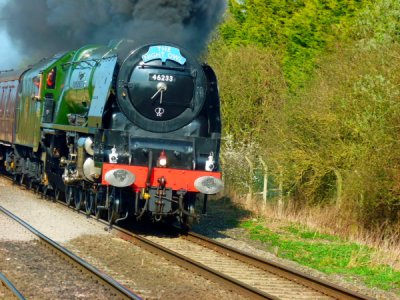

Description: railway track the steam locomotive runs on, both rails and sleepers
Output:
[0,175,374,299]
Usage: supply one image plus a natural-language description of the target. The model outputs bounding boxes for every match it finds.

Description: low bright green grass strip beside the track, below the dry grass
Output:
[240,219,400,294]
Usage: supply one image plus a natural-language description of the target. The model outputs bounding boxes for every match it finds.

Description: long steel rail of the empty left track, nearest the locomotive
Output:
[0,206,141,299]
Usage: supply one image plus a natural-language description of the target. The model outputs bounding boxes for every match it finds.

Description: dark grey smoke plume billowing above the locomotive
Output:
[0,0,226,63]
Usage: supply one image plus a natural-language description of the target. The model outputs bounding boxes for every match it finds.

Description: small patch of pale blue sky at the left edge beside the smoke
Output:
[0,0,21,71]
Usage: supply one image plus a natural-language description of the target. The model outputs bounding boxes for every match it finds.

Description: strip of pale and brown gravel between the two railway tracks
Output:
[0,178,247,300]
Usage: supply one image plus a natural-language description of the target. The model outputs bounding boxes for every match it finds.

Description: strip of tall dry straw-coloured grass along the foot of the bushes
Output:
[231,194,400,271]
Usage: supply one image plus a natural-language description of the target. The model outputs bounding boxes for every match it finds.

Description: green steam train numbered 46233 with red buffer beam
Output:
[0,41,223,227]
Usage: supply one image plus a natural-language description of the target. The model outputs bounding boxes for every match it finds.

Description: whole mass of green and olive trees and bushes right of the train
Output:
[209,0,400,226]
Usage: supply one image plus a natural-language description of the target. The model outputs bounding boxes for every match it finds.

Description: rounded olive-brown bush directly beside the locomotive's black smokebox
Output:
[208,43,286,144]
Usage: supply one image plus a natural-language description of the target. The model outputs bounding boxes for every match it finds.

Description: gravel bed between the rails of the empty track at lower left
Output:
[0,213,126,300]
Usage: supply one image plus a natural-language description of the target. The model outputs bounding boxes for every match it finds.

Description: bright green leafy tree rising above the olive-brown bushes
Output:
[220,0,371,91]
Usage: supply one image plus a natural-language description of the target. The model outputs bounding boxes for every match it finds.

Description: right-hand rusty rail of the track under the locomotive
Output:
[181,228,375,300]
